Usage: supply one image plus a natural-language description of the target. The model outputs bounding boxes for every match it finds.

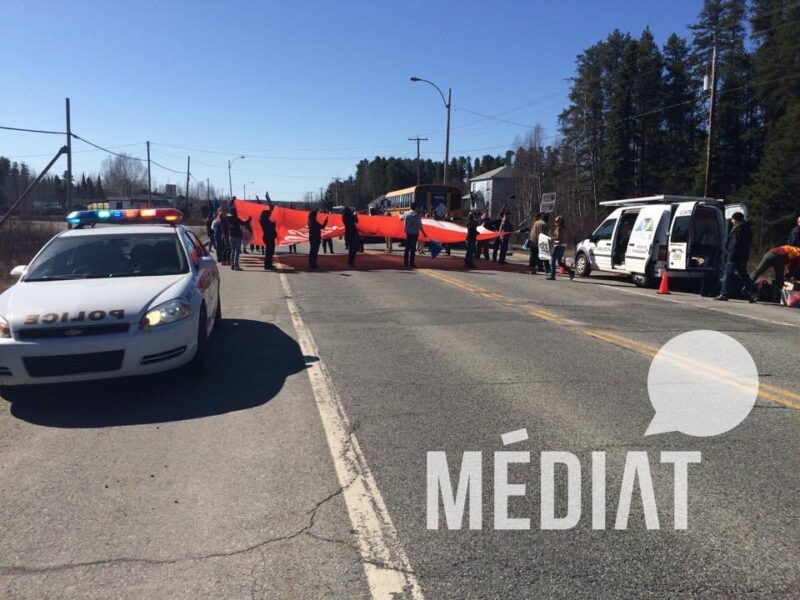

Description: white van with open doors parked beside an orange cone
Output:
[575,195,744,287]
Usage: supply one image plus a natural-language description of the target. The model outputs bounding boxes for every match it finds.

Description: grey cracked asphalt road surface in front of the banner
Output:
[0,246,800,598]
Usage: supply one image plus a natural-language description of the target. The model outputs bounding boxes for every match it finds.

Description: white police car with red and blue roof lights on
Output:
[0,209,221,386]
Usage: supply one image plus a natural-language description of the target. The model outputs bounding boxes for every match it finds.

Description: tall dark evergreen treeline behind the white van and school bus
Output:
[325,0,800,239]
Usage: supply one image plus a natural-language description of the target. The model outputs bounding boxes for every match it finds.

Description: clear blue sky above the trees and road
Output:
[0,0,701,200]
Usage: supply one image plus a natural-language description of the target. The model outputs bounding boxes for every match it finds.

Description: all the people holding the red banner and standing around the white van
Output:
[206,199,800,302]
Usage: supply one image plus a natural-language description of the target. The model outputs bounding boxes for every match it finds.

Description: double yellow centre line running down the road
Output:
[417,269,800,409]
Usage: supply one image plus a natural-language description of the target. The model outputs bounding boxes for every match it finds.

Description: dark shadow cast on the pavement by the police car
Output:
[2,319,308,428]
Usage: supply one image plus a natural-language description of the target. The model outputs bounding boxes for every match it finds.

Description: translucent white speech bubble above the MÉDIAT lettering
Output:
[645,330,758,437]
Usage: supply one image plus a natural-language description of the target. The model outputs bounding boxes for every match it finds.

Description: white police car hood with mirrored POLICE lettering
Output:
[0,273,191,329]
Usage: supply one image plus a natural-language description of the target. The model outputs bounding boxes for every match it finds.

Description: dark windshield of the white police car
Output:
[25,233,189,281]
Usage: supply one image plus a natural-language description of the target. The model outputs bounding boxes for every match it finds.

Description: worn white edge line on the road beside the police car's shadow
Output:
[280,273,424,600]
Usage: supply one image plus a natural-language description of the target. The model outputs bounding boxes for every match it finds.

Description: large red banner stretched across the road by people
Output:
[236,200,502,246]
